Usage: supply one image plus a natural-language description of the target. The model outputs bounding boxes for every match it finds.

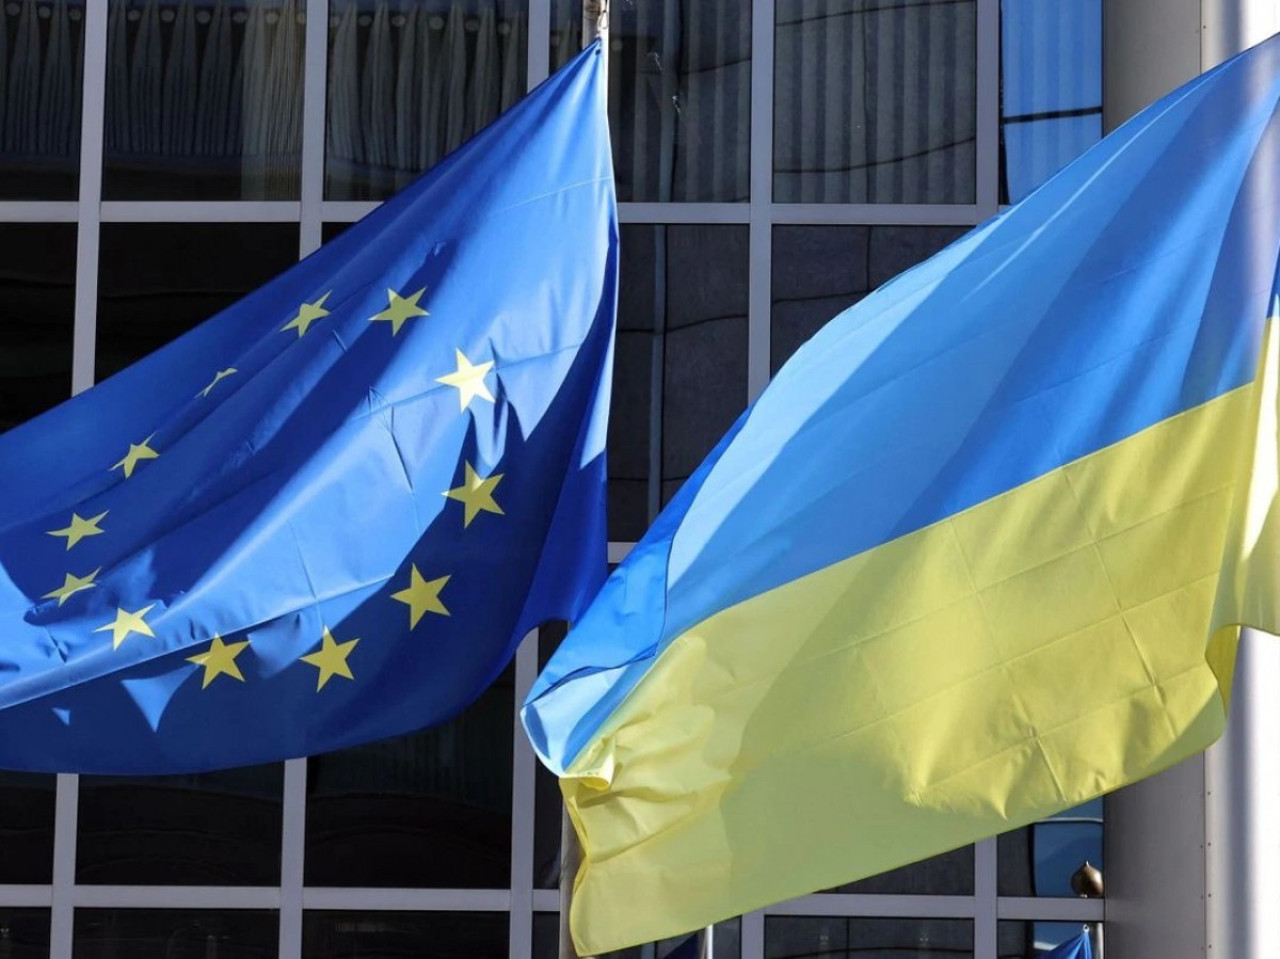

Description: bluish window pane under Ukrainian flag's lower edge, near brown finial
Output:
[996,799,1106,896]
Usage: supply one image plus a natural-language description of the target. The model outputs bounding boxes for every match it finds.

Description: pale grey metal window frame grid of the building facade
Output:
[0,0,1105,959]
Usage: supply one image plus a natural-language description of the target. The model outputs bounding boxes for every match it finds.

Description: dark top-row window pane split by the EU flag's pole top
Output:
[552,0,751,201]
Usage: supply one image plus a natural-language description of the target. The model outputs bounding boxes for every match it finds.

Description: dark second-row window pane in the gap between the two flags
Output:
[609,224,748,542]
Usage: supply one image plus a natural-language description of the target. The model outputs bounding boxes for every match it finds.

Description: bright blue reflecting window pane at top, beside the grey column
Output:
[1000,0,1102,204]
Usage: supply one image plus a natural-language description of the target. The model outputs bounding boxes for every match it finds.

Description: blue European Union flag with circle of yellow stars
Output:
[0,46,617,773]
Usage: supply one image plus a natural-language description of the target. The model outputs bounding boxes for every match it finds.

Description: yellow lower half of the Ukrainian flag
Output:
[561,358,1276,955]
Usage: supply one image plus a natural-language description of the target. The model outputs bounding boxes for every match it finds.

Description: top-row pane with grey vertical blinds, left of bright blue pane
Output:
[773,0,978,204]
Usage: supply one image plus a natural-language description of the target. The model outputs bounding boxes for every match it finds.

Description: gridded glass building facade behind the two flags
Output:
[0,0,1259,959]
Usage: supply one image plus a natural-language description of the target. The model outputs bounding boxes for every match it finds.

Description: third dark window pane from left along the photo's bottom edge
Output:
[302,910,511,959]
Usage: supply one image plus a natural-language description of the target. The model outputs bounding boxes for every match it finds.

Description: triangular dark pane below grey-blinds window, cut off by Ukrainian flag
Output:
[769,227,965,373]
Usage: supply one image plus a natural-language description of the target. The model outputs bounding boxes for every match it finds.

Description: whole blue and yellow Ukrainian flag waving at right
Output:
[524,33,1280,955]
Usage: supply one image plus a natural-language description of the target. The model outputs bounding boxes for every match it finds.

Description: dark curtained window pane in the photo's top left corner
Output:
[0,0,84,200]
